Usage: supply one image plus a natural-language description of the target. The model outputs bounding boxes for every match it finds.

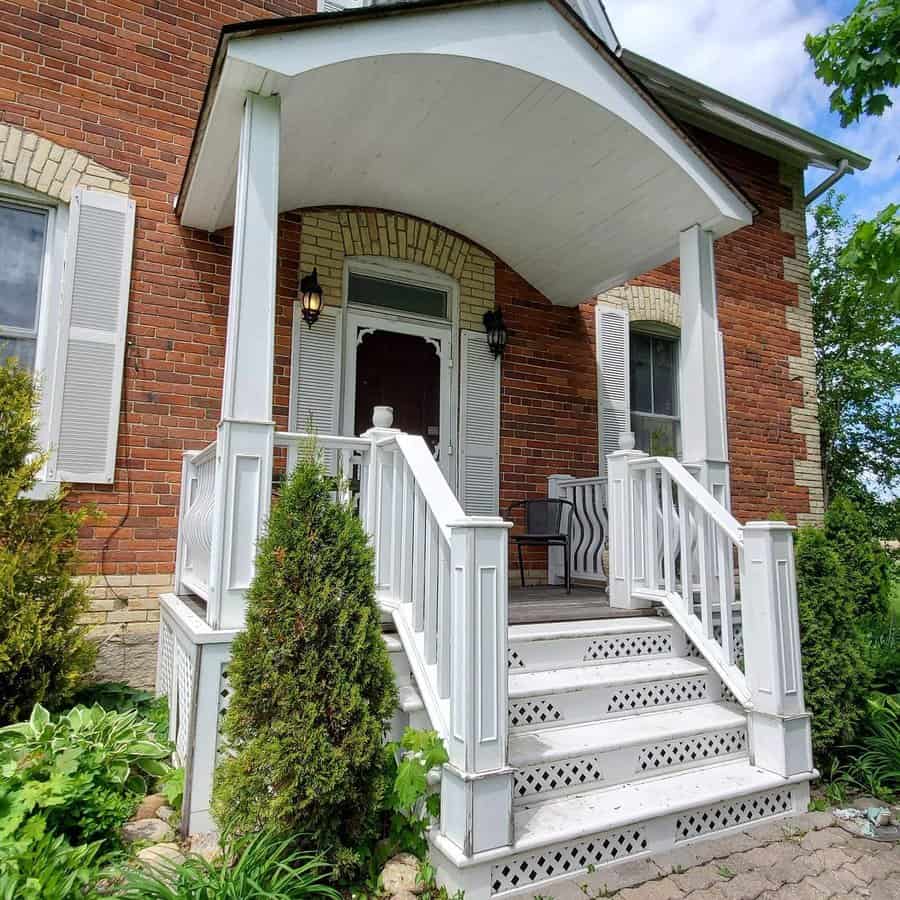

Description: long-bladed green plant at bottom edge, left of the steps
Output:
[116,830,341,900]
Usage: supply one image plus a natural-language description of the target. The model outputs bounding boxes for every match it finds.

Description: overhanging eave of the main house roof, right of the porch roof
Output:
[621,48,871,171]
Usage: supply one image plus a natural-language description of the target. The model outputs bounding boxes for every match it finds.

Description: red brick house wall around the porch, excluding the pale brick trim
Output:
[0,0,807,574]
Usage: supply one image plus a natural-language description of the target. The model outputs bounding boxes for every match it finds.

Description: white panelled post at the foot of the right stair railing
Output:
[741,522,812,776]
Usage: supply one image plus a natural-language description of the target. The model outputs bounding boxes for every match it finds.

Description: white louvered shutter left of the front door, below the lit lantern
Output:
[290,303,343,434]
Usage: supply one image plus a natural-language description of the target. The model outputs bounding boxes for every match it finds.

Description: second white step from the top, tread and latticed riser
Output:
[509,657,721,731]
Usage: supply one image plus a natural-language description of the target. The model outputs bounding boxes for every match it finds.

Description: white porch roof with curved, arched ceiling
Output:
[179,0,752,305]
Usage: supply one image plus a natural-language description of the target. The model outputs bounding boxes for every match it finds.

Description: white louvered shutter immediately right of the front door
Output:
[459,331,500,516]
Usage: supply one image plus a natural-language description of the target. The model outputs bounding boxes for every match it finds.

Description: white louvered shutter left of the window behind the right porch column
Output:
[594,303,631,474]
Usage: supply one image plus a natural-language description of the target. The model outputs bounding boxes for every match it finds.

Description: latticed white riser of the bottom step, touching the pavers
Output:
[490,783,809,897]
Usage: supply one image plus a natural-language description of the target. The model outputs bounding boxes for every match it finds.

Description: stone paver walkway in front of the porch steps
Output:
[534,812,900,900]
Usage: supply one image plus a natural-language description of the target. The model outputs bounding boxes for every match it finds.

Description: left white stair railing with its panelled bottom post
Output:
[364,428,512,855]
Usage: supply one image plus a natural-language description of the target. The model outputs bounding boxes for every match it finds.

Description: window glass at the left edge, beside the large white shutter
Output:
[0,200,49,369]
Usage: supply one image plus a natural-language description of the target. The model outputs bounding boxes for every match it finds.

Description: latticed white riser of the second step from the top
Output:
[509,674,721,732]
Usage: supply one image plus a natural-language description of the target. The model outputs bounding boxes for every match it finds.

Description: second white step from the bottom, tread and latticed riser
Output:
[509,703,748,806]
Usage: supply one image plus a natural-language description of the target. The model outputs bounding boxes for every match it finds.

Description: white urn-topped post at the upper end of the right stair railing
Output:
[606,431,651,609]
